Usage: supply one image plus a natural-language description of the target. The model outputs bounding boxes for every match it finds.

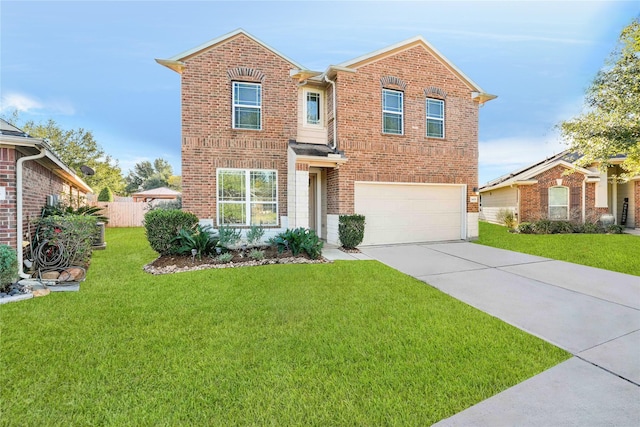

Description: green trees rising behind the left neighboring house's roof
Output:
[11,112,125,193]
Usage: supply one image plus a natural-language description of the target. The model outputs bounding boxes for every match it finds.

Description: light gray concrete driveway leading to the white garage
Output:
[361,242,640,426]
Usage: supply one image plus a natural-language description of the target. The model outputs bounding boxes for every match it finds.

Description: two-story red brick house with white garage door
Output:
[156,30,495,244]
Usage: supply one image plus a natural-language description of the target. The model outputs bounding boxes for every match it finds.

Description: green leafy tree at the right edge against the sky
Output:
[560,18,640,178]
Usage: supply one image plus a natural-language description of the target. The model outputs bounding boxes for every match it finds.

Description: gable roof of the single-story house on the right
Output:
[480,150,599,193]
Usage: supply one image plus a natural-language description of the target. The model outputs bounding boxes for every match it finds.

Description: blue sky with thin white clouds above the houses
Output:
[0,0,640,184]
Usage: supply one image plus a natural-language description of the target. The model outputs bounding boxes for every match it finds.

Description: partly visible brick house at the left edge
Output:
[0,119,91,248]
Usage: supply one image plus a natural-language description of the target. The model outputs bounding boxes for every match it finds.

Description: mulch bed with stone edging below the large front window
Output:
[143,247,328,274]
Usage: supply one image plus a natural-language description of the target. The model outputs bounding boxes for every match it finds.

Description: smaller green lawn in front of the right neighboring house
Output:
[477,222,640,276]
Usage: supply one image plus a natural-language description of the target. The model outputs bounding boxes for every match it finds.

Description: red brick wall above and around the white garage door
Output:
[328,46,478,214]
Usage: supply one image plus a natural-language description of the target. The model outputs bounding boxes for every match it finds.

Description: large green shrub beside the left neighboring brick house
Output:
[36,214,98,268]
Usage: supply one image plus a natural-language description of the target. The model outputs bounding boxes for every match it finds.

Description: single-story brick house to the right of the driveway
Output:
[480,150,640,228]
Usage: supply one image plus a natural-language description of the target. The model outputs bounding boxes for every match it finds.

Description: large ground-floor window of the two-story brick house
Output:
[218,169,278,225]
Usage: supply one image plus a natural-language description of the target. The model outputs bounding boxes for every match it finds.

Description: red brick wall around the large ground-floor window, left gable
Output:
[182,34,297,224]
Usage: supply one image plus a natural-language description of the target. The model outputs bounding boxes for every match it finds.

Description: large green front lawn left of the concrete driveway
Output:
[0,229,569,426]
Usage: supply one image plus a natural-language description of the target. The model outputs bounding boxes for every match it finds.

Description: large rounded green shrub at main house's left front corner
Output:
[144,209,198,255]
